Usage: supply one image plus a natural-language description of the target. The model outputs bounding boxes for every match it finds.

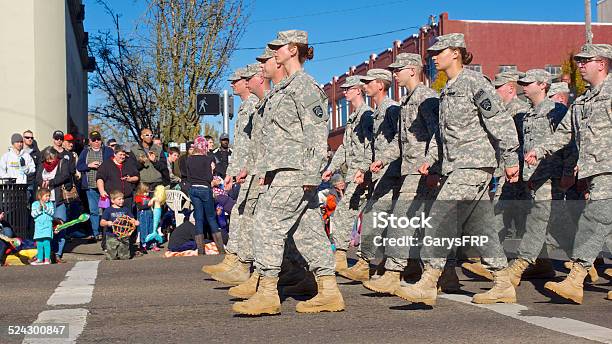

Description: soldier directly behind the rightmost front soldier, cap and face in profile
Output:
[508,69,575,287]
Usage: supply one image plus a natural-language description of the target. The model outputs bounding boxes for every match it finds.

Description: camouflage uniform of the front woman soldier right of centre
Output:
[421,65,518,270]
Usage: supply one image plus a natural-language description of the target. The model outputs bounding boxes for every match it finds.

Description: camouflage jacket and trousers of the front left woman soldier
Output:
[253,70,335,277]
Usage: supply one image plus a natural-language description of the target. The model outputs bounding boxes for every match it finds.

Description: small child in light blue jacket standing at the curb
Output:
[32,188,55,265]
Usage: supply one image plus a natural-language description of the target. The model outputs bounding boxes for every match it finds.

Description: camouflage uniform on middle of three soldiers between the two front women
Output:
[358,69,406,270]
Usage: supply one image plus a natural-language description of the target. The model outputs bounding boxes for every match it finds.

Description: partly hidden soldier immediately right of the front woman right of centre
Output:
[461,71,530,280]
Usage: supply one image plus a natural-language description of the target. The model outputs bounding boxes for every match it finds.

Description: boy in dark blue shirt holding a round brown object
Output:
[100,191,140,260]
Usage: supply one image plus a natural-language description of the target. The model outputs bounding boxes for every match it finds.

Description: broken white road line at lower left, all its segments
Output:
[23,261,100,344]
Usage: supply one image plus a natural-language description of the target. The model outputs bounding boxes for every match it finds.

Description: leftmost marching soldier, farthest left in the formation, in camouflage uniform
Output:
[202,66,258,284]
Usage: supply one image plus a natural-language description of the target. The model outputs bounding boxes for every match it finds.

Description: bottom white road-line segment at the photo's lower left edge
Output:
[23,308,89,344]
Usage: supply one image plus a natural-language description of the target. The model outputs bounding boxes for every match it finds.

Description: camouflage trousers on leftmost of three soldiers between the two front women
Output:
[331,179,368,251]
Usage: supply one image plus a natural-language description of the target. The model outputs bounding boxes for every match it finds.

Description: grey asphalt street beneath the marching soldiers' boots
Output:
[0,241,612,343]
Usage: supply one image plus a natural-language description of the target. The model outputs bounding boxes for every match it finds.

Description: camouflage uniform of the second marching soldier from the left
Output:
[226,63,259,262]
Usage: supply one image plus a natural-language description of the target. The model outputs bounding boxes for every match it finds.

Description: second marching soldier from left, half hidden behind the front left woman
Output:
[211,63,268,285]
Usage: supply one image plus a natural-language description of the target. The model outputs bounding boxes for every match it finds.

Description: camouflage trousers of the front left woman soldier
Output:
[253,171,335,277]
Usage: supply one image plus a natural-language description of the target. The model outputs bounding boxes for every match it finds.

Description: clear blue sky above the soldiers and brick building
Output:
[83,0,597,140]
